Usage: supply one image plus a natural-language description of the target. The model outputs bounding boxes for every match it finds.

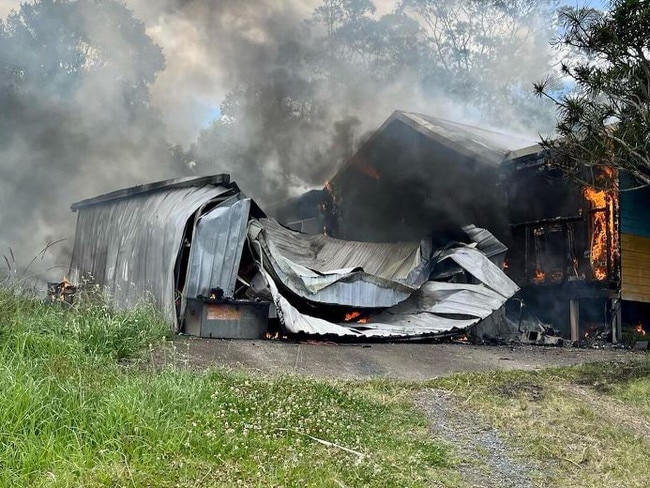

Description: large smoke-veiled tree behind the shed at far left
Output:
[0,0,181,278]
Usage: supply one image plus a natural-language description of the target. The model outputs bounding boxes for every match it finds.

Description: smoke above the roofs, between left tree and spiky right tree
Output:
[129,0,552,204]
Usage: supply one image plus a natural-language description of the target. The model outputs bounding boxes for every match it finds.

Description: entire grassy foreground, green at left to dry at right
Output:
[0,289,650,487]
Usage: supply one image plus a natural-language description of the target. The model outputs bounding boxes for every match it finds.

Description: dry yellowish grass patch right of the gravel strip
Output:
[427,356,650,488]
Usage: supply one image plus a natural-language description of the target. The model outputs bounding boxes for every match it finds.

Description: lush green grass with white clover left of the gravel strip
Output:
[0,290,453,487]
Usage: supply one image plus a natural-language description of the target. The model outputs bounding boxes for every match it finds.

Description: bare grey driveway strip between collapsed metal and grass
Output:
[156,336,639,380]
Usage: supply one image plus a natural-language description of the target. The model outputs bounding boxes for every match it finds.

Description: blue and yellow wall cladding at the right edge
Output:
[620,175,650,303]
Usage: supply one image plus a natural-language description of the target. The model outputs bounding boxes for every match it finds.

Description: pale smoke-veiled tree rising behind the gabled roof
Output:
[400,0,556,128]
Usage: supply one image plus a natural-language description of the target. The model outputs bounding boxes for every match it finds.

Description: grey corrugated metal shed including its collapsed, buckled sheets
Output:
[70,175,518,339]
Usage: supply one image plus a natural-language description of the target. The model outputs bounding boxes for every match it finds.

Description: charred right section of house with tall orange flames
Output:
[502,151,620,341]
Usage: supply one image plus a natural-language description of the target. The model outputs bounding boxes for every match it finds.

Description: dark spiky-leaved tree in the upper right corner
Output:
[535,0,650,189]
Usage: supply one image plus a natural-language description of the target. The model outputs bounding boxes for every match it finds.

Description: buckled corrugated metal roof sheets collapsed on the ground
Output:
[249,219,519,338]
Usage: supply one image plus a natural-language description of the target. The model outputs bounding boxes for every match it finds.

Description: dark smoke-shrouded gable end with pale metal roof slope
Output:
[323,111,533,245]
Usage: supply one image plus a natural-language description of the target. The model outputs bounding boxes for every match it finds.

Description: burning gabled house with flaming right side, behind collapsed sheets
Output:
[272,111,650,340]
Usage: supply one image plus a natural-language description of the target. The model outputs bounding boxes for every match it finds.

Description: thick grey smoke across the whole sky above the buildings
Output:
[0,0,550,278]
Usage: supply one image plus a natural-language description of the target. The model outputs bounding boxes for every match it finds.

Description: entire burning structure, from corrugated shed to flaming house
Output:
[64,112,650,344]
